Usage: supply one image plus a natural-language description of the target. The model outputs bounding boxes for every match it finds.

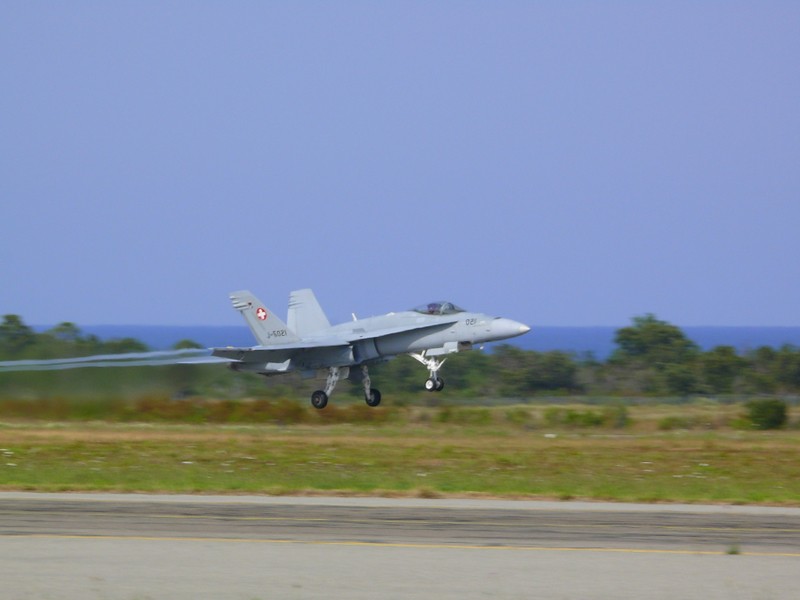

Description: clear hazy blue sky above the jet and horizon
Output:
[0,1,800,326]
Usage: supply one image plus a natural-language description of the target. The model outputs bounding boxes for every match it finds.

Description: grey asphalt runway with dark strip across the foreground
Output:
[0,492,800,600]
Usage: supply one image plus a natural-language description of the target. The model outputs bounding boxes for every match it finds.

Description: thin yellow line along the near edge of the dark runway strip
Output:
[6,534,800,558]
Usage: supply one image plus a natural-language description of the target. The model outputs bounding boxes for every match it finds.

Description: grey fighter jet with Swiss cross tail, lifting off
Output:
[210,289,530,408]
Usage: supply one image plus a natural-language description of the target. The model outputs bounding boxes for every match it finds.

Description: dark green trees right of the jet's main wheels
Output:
[376,314,800,397]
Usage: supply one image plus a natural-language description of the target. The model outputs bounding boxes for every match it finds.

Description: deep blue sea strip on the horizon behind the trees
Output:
[64,325,800,360]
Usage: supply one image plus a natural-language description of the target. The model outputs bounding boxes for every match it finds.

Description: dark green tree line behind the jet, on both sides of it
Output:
[0,314,800,398]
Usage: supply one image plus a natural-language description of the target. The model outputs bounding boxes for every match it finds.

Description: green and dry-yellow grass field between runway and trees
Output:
[0,407,800,505]
